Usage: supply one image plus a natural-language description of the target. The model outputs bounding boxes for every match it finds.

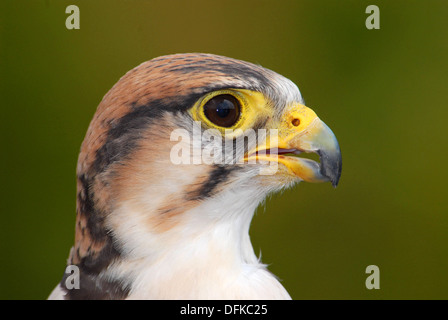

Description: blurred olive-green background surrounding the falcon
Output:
[0,0,448,299]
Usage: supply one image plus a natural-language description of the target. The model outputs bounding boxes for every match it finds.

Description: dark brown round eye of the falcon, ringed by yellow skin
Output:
[204,94,241,128]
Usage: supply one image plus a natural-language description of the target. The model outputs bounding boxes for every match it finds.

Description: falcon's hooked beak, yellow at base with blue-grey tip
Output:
[246,104,342,187]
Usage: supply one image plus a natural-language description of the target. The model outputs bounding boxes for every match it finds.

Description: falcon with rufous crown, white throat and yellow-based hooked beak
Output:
[49,53,342,299]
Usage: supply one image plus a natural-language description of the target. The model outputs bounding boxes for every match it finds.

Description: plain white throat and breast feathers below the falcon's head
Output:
[107,182,291,299]
